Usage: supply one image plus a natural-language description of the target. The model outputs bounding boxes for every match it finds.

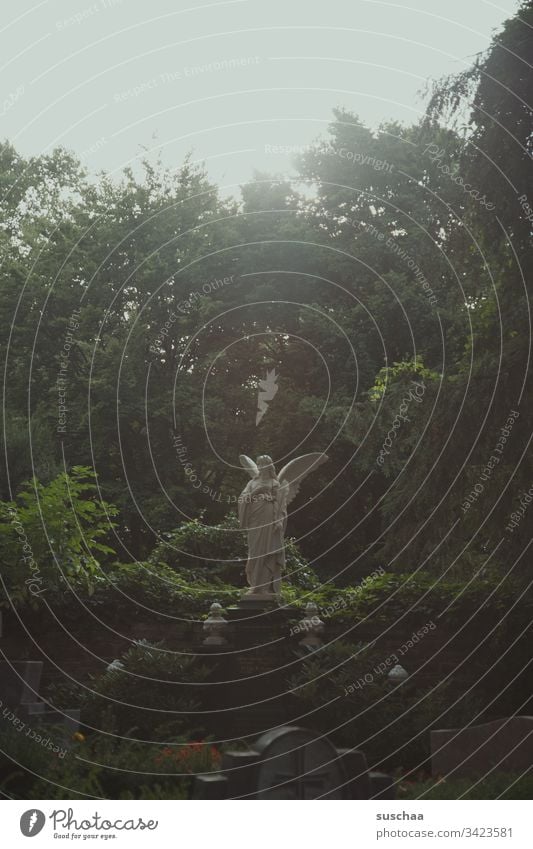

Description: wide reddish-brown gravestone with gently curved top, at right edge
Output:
[430,716,533,778]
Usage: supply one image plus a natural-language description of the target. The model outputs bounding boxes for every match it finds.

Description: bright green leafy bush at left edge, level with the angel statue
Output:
[0,466,117,606]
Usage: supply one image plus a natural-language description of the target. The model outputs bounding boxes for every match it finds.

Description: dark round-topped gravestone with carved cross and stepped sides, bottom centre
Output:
[193,726,394,800]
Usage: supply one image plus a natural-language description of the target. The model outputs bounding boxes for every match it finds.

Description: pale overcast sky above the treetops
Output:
[0,0,518,191]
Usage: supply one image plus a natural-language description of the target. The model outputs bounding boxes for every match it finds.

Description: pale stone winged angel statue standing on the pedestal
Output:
[239,454,328,600]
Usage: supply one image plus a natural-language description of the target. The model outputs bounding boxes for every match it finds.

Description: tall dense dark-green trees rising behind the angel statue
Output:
[0,3,533,583]
